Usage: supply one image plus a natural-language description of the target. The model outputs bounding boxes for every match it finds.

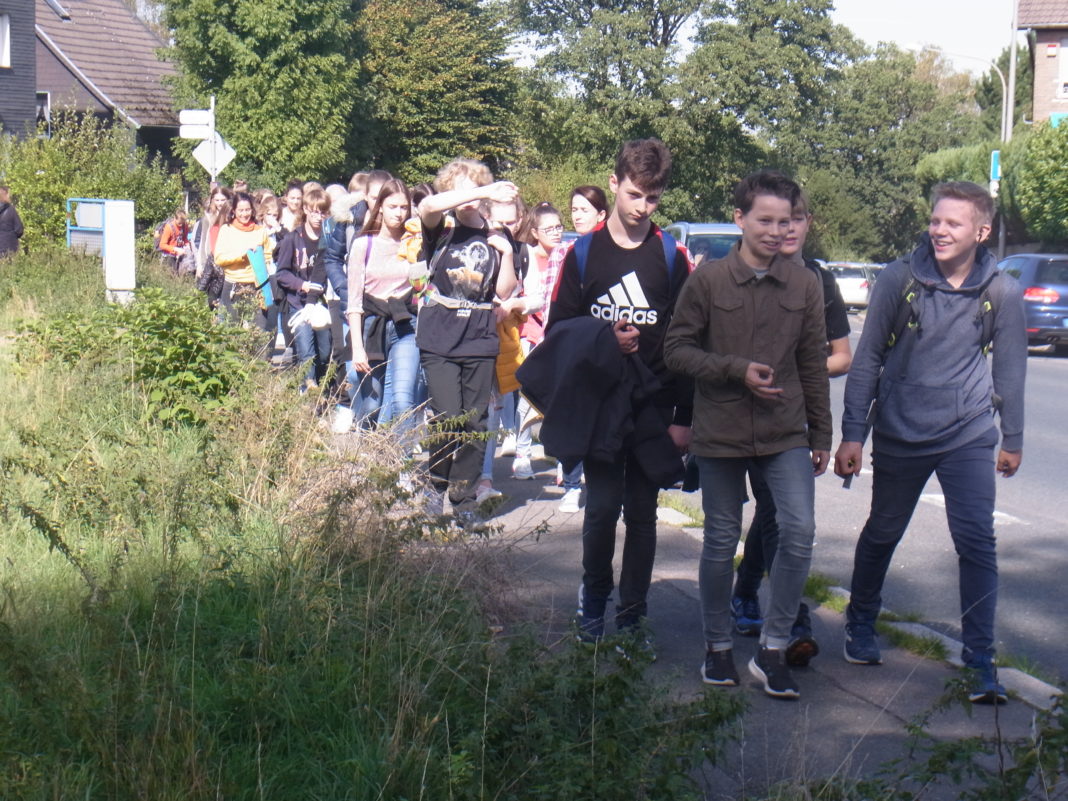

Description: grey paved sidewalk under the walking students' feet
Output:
[482,460,1059,799]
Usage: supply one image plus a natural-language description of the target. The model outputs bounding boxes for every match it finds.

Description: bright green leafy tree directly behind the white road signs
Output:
[166,0,362,185]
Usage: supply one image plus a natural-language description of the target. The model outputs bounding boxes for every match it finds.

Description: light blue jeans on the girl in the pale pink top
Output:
[349,319,419,434]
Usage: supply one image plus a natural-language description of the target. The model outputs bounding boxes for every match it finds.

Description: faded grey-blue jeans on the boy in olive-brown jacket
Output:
[697,447,816,648]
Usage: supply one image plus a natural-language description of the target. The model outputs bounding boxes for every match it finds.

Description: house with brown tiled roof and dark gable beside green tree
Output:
[34,0,178,154]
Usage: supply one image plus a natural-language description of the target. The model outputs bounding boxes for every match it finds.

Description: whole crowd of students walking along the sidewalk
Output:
[164,139,1026,703]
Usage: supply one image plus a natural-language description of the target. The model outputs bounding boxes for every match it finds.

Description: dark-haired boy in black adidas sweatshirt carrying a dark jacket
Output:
[547,139,693,641]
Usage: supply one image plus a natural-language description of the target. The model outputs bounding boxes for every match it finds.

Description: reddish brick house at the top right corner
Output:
[1017,0,1068,123]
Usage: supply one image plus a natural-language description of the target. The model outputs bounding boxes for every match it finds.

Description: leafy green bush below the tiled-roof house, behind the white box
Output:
[0,112,182,252]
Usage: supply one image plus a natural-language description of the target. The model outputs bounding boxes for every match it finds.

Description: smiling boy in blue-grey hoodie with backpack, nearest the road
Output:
[834,182,1027,704]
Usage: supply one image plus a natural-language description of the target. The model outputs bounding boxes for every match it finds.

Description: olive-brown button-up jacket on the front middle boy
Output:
[664,245,832,457]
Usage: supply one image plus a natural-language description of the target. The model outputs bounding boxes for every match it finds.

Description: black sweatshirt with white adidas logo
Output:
[548,225,692,414]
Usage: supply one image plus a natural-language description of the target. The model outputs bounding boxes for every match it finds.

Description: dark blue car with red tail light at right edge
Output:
[998,253,1068,348]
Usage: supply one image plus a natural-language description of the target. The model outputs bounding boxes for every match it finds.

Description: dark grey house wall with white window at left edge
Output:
[0,0,36,135]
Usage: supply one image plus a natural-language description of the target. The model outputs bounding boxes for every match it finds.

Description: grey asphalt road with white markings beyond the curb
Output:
[813,315,1068,682]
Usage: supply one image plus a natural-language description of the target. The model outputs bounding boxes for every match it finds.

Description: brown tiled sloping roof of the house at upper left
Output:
[36,0,178,127]
